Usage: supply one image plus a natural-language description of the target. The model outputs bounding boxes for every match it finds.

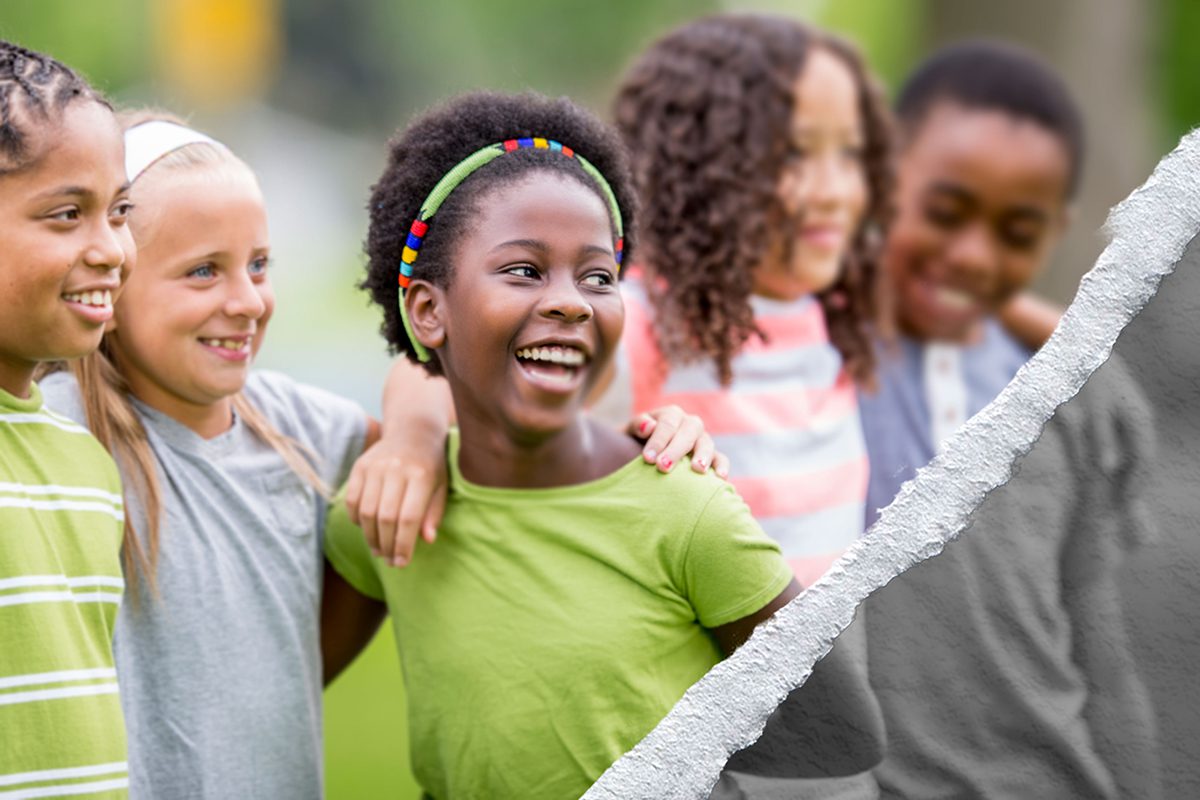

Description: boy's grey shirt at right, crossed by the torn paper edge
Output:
[860,330,1157,800]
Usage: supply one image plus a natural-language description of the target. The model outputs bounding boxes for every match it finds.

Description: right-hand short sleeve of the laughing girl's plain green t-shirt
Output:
[683,483,792,628]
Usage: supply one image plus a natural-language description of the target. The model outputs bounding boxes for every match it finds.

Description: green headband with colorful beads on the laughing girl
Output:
[400,137,625,362]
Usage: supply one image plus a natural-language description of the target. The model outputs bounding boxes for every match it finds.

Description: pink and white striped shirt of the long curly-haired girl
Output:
[593,276,868,587]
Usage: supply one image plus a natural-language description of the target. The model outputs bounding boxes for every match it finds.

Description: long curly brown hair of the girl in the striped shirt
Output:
[616,14,894,387]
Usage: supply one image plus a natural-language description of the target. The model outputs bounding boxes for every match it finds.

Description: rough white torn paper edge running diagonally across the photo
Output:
[583,131,1200,800]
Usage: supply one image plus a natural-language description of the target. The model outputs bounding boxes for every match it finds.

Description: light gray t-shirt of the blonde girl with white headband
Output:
[41,372,366,800]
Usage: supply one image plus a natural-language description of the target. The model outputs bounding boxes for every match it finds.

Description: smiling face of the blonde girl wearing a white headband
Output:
[113,167,275,434]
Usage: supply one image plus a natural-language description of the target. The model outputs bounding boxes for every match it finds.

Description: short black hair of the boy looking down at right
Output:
[896,40,1084,198]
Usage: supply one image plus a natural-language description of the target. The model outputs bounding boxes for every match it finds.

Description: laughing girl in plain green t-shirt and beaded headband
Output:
[326,94,798,800]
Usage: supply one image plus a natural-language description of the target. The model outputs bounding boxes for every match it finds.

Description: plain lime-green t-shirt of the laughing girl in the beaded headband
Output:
[325,434,791,800]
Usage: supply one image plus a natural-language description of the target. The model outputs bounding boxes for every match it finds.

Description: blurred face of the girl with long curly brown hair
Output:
[754,47,868,300]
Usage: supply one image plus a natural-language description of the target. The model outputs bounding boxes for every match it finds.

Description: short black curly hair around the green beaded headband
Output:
[360,92,637,374]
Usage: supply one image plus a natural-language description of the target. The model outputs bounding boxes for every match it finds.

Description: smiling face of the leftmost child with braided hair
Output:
[0,101,136,395]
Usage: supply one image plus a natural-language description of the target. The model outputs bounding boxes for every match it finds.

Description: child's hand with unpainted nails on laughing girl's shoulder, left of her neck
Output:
[346,431,446,566]
